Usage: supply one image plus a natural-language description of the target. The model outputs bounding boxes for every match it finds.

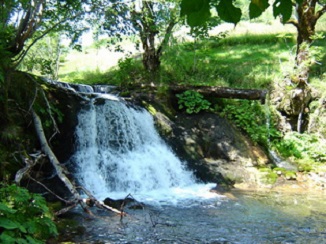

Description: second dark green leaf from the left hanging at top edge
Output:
[216,0,241,24]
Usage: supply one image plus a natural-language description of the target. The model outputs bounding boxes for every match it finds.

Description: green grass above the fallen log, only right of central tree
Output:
[162,34,294,88]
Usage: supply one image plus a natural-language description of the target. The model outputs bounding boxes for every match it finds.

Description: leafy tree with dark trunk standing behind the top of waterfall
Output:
[103,0,179,74]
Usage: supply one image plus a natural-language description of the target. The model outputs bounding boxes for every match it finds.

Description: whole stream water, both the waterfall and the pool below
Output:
[70,96,326,243]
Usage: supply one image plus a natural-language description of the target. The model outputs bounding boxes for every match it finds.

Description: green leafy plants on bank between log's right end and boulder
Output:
[220,100,280,148]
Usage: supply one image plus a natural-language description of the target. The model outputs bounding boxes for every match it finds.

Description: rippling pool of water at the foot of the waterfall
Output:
[63,191,326,243]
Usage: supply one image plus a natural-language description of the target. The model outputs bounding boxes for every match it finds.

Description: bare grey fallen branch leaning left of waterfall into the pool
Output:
[30,110,125,216]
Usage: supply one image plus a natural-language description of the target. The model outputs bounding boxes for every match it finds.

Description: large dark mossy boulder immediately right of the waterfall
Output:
[154,112,268,186]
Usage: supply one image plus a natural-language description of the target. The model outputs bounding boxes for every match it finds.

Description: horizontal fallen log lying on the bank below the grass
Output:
[170,86,267,104]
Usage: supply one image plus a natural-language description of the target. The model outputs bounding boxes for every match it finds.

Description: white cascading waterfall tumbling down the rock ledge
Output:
[71,100,216,201]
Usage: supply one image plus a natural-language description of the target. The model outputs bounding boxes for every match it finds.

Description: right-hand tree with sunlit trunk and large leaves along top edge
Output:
[181,0,326,132]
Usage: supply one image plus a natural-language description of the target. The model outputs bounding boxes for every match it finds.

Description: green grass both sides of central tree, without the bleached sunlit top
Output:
[60,31,310,88]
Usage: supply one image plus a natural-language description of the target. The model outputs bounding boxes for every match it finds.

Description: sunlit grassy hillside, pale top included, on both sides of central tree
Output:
[60,21,326,88]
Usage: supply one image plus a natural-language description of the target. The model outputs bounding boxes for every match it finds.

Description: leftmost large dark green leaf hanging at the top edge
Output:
[180,0,211,27]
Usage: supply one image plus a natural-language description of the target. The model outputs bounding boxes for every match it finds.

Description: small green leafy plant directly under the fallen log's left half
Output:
[176,90,211,114]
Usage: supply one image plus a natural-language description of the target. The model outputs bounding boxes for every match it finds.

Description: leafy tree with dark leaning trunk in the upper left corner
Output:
[0,0,99,127]
